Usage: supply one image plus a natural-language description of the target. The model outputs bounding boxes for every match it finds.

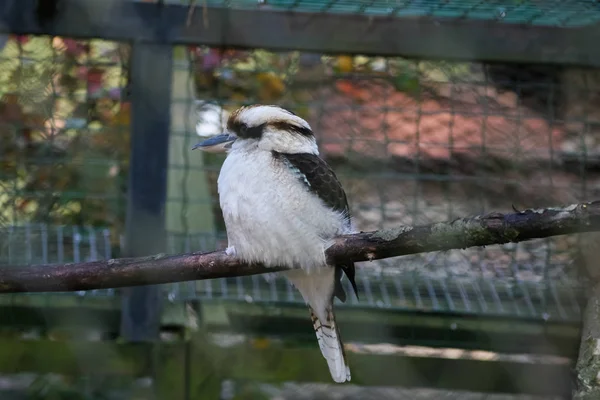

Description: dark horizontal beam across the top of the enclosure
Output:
[0,0,600,66]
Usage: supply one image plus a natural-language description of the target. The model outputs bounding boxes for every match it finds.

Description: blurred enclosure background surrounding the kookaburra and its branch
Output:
[0,0,600,400]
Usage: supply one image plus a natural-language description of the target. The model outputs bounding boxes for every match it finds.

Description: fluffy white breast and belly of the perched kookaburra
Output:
[218,149,346,270]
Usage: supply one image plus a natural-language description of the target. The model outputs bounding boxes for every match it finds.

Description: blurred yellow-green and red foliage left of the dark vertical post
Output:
[0,36,129,236]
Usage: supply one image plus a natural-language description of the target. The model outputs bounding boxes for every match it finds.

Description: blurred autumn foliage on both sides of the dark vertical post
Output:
[0,36,468,232]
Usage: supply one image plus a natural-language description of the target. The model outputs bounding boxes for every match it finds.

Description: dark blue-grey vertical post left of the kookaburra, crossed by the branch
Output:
[121,43,173,341]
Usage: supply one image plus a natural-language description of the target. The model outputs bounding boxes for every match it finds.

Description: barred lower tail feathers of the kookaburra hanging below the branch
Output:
[308,304,350,383]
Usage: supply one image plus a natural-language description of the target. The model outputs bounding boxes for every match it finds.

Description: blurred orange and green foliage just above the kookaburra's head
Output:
[189,47,458,118]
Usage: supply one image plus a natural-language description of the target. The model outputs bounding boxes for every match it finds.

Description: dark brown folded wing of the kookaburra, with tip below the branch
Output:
[273,151,358,302]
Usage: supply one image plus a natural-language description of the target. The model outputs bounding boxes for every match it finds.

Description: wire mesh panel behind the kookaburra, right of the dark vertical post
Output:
[162,48,597,321]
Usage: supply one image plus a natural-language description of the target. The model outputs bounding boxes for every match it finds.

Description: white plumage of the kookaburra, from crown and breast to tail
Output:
[218,106,352,382]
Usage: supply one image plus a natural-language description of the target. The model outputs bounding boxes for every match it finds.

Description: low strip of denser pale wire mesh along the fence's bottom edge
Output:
[0,224,582,321]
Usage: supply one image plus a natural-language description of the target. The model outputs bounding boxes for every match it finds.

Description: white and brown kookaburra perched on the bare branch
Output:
[193,104,358,383]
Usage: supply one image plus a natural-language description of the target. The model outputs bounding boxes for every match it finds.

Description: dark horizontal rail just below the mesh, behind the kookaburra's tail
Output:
[212,301,579,357]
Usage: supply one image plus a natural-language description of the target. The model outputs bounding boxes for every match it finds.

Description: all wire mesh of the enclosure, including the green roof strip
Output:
[0,8,600,398]
